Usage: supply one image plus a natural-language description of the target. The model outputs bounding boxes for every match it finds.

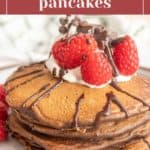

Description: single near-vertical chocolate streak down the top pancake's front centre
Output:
[73,94,84,129]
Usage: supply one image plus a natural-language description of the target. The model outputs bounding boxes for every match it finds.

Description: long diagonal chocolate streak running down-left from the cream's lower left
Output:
[30,80,63,107]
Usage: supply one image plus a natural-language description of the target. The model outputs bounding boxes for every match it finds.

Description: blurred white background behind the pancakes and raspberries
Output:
[0,15,150,83]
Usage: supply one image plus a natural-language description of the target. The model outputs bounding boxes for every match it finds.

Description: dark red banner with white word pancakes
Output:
[0,0,150,14]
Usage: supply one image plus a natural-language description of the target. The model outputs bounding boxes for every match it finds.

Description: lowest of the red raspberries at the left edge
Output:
[0,121,8,142]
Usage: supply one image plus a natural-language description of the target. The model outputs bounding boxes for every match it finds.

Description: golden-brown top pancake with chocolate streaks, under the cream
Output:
[5,63,150,128]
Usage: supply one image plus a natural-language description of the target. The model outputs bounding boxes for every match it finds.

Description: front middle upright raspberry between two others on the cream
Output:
[81,52,112,85]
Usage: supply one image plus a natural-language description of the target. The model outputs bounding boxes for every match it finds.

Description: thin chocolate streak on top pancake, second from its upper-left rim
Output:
[7,72,45,94]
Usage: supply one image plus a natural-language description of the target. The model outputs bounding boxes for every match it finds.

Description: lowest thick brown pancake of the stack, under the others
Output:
[9,115,150,150]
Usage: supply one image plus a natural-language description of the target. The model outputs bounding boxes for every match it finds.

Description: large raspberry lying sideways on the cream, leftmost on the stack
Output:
[52,33,97,69]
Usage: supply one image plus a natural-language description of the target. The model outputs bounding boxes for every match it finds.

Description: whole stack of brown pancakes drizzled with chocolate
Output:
[5,62,150,150]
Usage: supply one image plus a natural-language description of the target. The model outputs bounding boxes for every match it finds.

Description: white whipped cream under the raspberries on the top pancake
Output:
[45,55,131,88]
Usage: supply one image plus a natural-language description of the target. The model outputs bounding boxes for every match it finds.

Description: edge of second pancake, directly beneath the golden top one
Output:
[14,111,150,140]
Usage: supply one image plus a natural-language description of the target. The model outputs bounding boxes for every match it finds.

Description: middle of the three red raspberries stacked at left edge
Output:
[0,101,8,121]
